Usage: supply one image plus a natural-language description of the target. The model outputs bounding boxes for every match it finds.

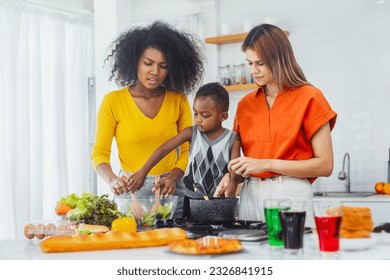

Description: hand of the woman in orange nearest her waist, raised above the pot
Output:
[228,157,266,178]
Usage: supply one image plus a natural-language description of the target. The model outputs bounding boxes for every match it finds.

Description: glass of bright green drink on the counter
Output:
[264,199,288,250]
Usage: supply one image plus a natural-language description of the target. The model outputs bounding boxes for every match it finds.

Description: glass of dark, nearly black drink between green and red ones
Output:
[279,201,306,254]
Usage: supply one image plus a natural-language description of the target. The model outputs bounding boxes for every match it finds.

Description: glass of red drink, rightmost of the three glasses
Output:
[313,200,343,257]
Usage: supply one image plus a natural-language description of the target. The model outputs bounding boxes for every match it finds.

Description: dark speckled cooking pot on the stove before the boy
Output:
[189,197,238,222]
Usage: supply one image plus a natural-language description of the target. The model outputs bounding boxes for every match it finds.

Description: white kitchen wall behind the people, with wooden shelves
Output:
[95,0,390,195]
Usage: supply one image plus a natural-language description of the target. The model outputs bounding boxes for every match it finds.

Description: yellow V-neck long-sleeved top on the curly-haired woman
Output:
[91,88,192,175]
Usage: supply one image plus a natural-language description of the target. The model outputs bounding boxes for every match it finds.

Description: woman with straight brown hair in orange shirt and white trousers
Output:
[215,24,336,226]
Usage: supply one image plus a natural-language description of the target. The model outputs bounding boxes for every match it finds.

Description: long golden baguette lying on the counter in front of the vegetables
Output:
[40,228,187,253]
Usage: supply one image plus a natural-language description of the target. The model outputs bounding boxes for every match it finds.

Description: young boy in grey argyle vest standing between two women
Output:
[128,83,240,217]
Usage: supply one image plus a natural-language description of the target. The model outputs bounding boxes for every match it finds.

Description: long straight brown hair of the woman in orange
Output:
[241,24,310,90]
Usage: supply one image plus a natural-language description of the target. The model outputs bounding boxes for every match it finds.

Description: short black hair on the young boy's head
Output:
[195,83,229,112]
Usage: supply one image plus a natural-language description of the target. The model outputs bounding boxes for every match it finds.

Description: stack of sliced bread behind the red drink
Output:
[340,206,374,238]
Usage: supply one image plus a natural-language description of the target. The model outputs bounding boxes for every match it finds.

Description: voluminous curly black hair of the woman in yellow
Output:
[105,21,204,93]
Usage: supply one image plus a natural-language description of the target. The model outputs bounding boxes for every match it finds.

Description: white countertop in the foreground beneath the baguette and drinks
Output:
[0,233,390,260]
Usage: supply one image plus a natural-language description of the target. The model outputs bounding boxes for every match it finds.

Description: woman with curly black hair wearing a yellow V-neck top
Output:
[91,21,204,217]
